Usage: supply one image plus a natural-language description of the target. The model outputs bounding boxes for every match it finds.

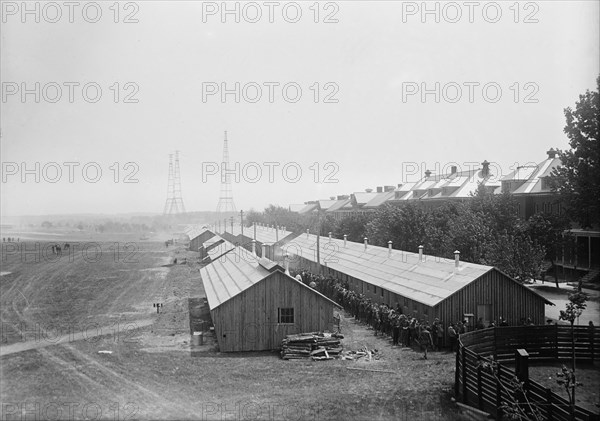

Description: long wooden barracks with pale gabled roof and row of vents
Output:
[281,233,552,342]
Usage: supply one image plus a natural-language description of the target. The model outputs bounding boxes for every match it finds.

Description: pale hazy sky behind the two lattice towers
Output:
[0,1,600,215]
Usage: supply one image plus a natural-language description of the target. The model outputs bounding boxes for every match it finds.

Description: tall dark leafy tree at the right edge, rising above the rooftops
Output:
[550,76,600,228]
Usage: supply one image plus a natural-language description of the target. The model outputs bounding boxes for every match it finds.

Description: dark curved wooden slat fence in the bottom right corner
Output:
[454,325,600,421]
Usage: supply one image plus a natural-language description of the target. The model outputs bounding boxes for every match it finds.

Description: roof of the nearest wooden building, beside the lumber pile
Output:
[200,247,339,310]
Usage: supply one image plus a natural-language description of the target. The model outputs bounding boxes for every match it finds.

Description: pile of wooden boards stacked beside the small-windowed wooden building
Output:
[281,332,343,360]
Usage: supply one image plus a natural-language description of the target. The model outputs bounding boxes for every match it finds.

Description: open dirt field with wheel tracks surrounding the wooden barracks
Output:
[0,239,460,420]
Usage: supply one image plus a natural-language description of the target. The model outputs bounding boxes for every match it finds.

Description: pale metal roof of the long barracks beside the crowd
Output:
[283,234,548,307]
